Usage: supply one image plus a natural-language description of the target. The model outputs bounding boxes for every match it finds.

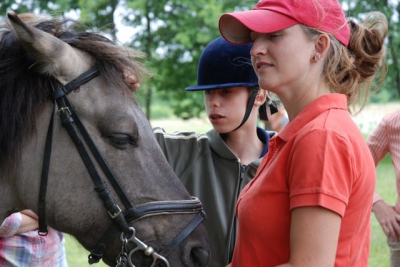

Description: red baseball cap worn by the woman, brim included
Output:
[219,0,350,47]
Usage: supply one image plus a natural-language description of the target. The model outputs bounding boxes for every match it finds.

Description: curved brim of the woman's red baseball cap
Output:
[218,9,299,44]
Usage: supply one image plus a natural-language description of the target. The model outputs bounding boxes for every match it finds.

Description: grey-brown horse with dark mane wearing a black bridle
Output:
[0,12,210,267]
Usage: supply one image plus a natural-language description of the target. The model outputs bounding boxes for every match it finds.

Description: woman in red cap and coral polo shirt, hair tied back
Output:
[219,0,387,267]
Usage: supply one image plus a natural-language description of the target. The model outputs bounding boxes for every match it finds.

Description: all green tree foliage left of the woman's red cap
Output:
[0,0,254,118]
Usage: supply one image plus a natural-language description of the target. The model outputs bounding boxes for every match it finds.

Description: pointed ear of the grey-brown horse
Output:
[7,12,91,83]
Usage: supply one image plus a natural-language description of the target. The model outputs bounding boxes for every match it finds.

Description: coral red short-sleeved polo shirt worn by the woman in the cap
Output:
[232,94,376,267]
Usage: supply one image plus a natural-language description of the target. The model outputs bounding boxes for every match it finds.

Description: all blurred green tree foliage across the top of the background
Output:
[0,0,400,118]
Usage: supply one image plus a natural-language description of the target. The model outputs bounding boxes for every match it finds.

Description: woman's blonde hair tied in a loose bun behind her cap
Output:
[303,12,388,113]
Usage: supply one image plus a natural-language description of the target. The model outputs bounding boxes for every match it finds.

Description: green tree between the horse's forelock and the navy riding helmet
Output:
[120,0,254,118]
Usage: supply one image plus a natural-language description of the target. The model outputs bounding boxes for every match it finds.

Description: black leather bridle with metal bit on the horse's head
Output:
[39,67,205,267]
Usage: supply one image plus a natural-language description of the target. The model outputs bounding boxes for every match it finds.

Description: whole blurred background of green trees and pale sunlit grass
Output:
[0,0,400,267]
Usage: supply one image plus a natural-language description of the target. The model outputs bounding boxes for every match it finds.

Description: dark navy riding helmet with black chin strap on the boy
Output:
[185,37,272,131]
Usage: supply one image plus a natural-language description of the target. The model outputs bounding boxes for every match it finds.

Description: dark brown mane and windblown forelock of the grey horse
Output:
[0,13,149,172]
